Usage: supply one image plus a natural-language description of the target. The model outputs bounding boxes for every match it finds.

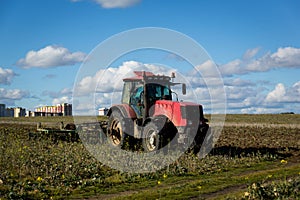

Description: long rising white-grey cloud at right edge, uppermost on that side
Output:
[220,47,300,76]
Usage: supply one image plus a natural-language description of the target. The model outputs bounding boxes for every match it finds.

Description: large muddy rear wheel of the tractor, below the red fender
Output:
[107,110,125,148]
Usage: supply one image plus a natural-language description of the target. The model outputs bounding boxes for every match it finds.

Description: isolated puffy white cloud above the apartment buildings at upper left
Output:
[16,45,86,69]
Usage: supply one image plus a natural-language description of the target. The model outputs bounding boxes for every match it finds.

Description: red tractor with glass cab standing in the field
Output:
[107,71,209,153]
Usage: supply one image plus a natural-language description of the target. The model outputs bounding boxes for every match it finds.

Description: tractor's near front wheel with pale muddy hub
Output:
[143,122,161,152]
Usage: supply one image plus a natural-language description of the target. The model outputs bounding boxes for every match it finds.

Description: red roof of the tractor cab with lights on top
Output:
[123,71,175,82]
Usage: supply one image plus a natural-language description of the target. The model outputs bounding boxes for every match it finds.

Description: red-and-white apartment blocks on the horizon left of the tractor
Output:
[34,103,72,116]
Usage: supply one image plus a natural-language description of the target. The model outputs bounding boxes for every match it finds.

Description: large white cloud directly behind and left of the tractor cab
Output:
[73,61,174,114]
